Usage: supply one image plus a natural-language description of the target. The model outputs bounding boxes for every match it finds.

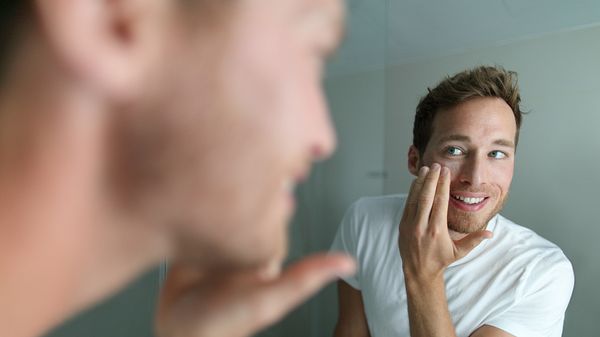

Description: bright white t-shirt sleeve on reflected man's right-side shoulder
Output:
[484,251,575,337]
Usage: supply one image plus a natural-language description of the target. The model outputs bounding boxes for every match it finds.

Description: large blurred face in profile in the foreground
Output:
[129,0,344,266]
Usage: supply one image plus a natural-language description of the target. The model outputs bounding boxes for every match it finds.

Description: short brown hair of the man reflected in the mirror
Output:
[413,66,523,155]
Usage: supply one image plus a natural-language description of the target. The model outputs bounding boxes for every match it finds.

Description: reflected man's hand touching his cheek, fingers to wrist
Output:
[398,164,492,282]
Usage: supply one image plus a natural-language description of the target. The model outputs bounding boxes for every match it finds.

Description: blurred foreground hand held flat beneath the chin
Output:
[156,254,355,337]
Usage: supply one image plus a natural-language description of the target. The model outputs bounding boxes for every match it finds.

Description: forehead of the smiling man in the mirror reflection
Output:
[431,97,517,143]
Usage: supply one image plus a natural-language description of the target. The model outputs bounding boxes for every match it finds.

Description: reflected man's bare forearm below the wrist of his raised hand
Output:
[405,275,456,337]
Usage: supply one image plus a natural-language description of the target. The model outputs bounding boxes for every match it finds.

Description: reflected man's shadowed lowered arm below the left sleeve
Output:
[334,281,371,337]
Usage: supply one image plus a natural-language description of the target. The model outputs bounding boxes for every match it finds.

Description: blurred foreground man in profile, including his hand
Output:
[0,0,353,337]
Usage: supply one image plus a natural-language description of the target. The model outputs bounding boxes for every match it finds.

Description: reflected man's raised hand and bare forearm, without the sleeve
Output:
[398,164,496,337]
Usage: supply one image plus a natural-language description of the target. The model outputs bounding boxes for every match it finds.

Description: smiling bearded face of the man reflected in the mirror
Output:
[411,97,516,233]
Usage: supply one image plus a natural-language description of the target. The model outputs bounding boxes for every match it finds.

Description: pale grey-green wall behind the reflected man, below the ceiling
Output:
[384,24,600,337]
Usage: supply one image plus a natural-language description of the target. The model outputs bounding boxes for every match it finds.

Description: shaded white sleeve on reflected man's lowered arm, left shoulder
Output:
[330,201,361,290]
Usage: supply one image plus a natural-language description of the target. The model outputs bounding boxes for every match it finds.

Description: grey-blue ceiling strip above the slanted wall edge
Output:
[327,0,600,77]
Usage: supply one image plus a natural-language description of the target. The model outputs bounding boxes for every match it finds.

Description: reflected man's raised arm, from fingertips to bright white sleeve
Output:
[398,167,574,337]
